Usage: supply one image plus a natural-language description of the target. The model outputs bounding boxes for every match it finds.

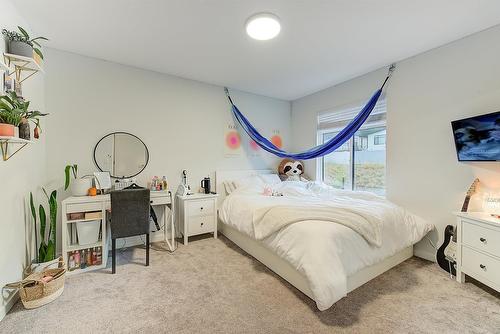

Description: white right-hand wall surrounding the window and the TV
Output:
[292,26,500,259]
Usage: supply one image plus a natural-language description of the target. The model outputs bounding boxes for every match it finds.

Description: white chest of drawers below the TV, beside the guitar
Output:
[456,212,500,291]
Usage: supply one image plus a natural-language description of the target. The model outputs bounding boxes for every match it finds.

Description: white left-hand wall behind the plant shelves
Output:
[0,0,47,320]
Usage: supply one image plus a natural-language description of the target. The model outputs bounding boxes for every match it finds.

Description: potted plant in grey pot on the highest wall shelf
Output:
[2,26,48,59]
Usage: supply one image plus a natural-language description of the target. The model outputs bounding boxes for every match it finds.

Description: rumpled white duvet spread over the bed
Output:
[219,182,433,310]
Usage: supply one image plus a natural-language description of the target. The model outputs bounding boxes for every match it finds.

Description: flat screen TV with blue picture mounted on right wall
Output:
[451,111,500,161]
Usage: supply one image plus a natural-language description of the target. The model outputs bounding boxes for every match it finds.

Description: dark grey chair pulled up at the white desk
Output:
[110,187,150,274]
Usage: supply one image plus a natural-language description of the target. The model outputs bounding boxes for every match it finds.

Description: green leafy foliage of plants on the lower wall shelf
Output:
[0,91,48,132]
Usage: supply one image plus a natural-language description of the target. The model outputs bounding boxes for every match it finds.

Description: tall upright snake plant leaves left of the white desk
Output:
[30,188,57,263]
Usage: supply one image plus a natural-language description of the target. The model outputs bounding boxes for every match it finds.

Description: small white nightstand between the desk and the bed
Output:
[177,194,218,245]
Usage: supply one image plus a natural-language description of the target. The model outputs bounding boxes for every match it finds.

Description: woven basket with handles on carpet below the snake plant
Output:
[6,257,66,309]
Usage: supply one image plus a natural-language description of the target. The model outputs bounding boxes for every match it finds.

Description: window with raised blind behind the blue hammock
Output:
[318,99,386,196]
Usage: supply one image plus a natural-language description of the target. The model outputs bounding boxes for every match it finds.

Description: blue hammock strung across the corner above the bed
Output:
[224,65,395,160]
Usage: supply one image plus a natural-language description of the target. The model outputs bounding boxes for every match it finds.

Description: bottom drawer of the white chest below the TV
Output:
[462,247,500,286]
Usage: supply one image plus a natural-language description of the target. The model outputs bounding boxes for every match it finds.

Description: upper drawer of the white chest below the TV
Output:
[462,220,500,257]
